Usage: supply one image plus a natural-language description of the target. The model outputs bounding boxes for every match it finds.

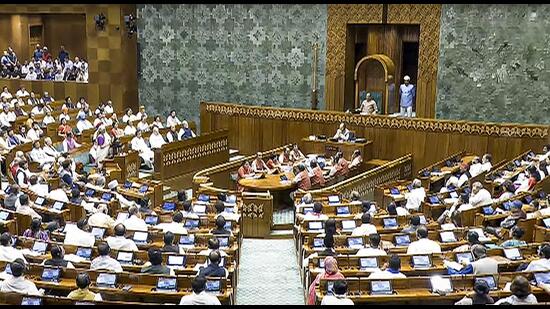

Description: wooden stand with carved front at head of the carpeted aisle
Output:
[241,191,273,238]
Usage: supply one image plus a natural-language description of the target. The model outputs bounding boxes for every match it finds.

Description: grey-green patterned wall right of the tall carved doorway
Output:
[436,4,550,124]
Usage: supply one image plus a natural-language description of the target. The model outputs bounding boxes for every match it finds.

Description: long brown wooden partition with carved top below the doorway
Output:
[201,102,550,173]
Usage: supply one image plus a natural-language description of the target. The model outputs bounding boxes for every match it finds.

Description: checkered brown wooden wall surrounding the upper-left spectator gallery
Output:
[0,4,138,110]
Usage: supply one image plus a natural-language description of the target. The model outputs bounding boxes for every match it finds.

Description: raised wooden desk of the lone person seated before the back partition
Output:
[301,137,373,162]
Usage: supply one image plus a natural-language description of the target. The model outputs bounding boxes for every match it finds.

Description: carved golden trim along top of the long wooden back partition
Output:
[201,102,550,138]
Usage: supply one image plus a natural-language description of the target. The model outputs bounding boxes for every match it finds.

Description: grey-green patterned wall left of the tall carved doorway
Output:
[138,4,327,123]
